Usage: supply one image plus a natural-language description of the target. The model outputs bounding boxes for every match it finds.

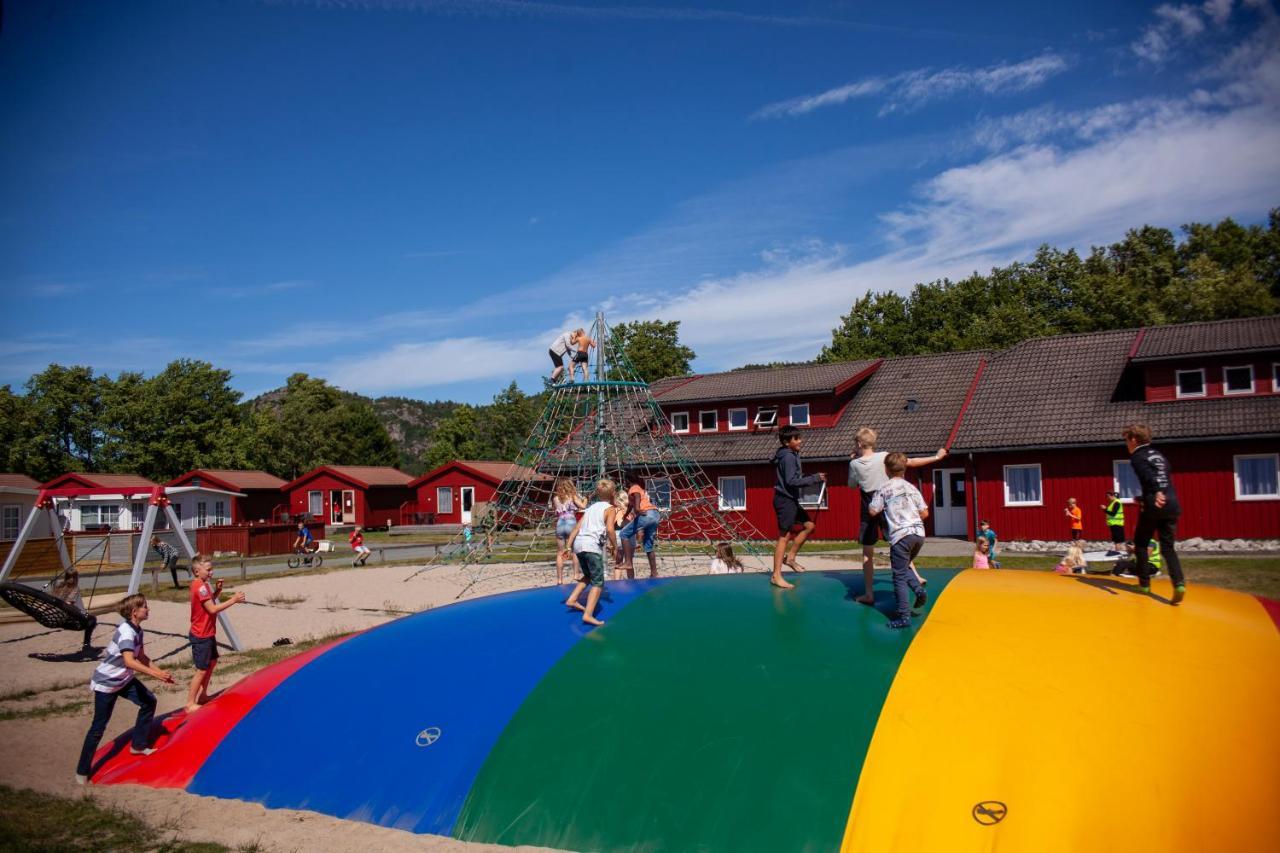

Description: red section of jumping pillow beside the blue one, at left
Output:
[92,637,349,788]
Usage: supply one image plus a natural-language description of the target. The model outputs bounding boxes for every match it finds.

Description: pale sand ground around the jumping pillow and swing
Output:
[0,555,856,853]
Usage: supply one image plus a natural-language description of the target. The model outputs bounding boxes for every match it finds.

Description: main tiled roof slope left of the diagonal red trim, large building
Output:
[680,352,988,466]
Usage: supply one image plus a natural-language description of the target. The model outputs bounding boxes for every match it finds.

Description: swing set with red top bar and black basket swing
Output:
[0,485,241,652]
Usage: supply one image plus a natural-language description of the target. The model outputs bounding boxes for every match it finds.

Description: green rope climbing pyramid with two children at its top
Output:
[410,308,767,597]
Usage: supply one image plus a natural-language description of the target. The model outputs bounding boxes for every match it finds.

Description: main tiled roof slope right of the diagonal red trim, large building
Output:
[952,324,1280,451]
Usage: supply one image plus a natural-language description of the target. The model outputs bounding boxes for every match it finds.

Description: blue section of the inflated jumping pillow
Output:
[187,579,664,835]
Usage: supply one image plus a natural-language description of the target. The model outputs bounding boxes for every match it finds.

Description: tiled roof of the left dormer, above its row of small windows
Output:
[649,359,876,405]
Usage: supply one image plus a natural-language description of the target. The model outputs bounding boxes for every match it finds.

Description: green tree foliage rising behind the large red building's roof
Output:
[818,209,1280,361]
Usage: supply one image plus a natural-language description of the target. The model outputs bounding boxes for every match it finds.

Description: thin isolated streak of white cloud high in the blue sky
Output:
[751,54,1068,119]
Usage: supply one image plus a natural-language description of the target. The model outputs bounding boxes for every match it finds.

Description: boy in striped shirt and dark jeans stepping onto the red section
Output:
[76,594,173,785]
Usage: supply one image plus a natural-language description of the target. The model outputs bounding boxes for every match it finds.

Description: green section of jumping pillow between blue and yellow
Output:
[453,563,956,853]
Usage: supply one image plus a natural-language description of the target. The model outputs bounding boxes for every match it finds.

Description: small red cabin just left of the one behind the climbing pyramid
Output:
[280,465,415,528]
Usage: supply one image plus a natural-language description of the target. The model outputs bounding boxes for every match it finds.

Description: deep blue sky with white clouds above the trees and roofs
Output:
[0,0,1280,402]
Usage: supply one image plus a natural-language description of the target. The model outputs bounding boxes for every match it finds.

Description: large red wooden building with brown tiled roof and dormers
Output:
[650,316,1280,539]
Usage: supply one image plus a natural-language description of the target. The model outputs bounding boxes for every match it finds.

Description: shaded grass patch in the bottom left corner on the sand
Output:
[0,785,240,853]
